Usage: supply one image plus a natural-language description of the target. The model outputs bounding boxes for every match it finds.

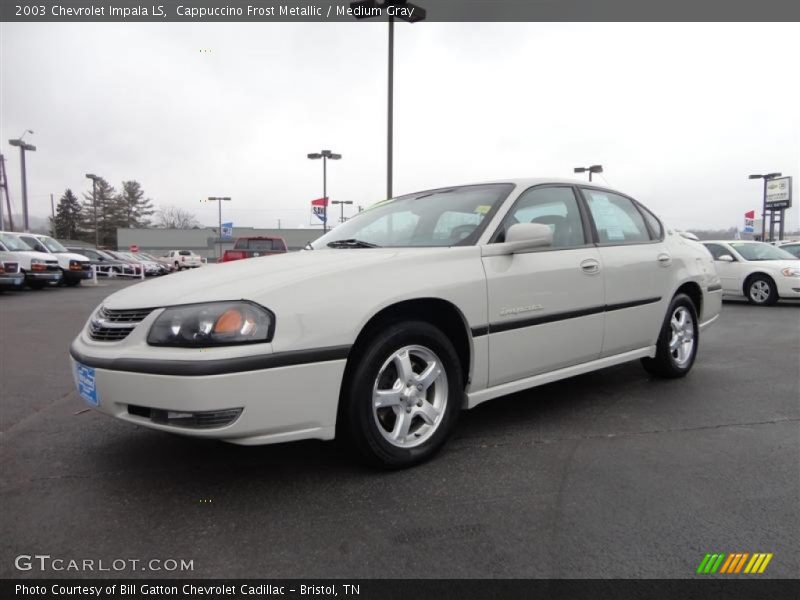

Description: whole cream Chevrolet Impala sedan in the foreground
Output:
[70,179,721,467]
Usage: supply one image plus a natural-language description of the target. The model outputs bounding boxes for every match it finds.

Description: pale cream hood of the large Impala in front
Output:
[104,247,462,309]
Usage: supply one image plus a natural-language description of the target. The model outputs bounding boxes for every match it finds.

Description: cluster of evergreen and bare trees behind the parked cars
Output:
[50,177,199,248]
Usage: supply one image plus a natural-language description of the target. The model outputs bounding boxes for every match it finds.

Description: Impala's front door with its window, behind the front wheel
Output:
[483,185,604,385]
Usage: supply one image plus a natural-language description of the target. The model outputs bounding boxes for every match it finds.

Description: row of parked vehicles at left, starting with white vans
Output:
[0,231,203,290]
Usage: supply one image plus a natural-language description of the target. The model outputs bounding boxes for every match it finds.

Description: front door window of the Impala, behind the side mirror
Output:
[493,187,586,248]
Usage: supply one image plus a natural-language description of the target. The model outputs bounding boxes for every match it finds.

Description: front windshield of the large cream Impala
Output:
[311,183,514,249]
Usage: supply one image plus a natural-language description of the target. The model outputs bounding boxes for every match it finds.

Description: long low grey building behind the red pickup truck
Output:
[111,227,322,260]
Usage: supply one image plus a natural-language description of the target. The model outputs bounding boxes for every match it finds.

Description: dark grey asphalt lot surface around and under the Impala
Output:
[0,281,800,578]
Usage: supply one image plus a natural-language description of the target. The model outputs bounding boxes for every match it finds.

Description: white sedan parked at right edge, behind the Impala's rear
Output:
[703,240,800,305]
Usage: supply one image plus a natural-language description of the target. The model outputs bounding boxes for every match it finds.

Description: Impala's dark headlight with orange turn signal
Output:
[147,301,275,348]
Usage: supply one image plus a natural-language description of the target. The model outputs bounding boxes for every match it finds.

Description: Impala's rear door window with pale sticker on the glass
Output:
[583,189,650,245]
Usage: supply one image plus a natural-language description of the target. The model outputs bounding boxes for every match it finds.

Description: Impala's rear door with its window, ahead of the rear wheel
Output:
[581,186,674,356]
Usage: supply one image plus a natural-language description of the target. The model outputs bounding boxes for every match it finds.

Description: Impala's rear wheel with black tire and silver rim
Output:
[642,294,700,379]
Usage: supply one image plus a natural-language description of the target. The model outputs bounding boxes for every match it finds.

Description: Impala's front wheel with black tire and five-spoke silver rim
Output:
[339,321,464,469]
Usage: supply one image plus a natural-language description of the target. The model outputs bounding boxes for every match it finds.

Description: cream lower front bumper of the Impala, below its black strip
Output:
[70,338,346,445]
